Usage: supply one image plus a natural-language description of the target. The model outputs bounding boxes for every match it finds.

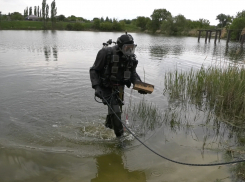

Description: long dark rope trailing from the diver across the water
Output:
[99,97,245,166]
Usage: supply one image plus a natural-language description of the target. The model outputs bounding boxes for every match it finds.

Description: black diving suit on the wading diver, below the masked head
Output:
[90,45,141,137]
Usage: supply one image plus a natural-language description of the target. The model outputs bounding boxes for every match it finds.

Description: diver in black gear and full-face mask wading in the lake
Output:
[89,33,146,137]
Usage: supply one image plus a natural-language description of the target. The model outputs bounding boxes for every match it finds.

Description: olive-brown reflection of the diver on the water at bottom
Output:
[91,153,146,182]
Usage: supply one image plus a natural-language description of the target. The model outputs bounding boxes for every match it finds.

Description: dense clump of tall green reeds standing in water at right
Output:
[165,65,245,124]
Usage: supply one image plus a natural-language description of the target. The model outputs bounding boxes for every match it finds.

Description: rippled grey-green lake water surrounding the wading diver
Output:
[0,31,245,182]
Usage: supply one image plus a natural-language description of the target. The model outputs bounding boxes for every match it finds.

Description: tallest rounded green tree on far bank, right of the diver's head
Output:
[151,9,172,32]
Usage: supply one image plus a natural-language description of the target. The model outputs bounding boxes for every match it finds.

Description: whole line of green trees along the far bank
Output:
[1,5,245,39]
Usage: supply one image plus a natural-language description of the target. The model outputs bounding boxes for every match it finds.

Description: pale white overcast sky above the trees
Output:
[0,0,245,25]
